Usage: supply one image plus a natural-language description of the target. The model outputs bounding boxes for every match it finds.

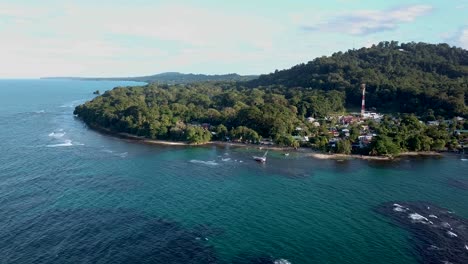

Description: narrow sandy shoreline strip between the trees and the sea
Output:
[86,124,443,161]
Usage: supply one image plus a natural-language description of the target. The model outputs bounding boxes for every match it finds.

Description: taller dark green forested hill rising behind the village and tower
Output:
[248,41,468,117]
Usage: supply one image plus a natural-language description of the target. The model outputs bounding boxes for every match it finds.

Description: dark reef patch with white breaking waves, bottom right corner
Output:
[376,202,468,264]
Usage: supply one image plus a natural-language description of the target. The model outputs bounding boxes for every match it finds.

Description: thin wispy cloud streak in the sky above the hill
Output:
[302,5,433,35]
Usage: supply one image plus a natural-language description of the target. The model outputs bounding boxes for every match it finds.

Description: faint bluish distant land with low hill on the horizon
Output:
[41,72,258,84]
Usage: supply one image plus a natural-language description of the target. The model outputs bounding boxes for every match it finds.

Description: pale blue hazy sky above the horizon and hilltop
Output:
[0,0,468,78]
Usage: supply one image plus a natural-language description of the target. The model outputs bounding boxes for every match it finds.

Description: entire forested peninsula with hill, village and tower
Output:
[74,41,468,157]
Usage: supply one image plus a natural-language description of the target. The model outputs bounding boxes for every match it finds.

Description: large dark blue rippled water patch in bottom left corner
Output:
[0,209,219,264]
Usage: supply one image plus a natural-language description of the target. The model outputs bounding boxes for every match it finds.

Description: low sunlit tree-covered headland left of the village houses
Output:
[75,82,344,145]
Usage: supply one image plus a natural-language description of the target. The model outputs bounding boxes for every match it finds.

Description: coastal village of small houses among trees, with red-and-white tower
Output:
[206,84,468,157]
